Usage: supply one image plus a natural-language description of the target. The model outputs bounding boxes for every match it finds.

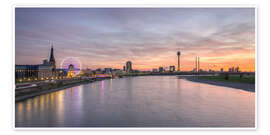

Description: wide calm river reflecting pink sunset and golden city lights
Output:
[15,76,255,127]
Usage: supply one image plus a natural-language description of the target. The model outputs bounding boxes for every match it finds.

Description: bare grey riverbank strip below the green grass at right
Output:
[181,76,255,92]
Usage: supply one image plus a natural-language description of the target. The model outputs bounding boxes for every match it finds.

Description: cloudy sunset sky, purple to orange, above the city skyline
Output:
[15,8,255,71]
